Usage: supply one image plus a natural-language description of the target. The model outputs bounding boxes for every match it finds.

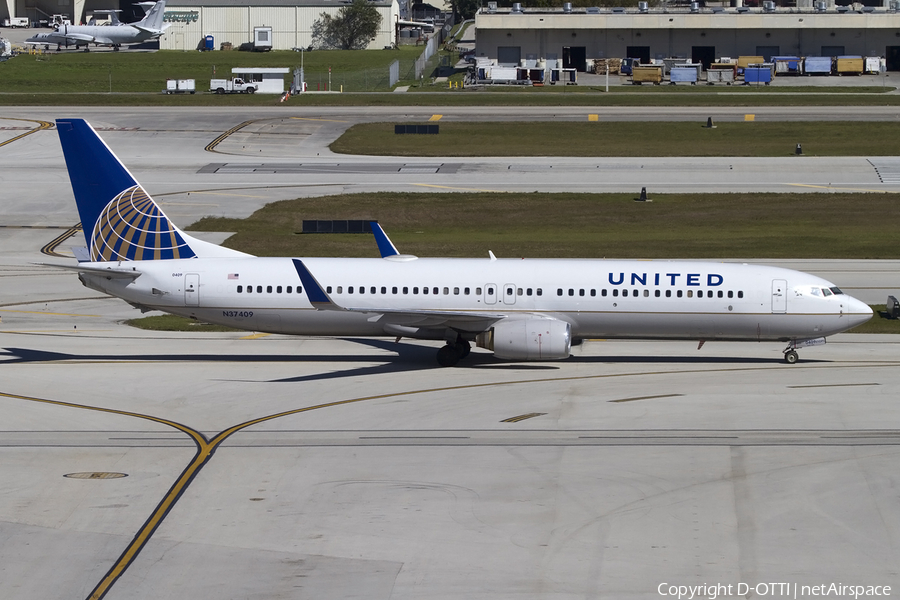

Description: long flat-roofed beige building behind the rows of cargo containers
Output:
[475,0,900,71]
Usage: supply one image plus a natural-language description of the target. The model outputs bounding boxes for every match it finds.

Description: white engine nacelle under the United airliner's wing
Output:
[475,319,572,360]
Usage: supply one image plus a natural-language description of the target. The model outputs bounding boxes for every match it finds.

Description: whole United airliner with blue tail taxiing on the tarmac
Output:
[47,119,872,366]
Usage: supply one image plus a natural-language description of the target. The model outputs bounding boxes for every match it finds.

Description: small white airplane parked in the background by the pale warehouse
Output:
[25,0,168,52]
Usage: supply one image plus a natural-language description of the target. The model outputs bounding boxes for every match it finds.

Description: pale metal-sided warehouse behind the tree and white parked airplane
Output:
[159,0,399,50]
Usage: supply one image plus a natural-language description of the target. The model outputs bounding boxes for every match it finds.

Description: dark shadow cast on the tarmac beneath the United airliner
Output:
[0,338,829,383]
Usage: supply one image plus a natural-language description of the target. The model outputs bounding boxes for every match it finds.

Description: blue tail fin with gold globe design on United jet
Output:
[56,119,199,262]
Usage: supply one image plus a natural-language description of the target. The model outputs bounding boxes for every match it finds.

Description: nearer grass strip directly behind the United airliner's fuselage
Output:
[191,189,900,259]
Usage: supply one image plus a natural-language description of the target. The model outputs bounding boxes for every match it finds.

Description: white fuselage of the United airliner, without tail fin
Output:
[82,256,872,341]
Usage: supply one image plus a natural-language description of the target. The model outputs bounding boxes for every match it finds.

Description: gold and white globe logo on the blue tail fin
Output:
[91,185,196,262]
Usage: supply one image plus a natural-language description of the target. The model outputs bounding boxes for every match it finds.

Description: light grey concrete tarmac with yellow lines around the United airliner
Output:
[0,110,900,600]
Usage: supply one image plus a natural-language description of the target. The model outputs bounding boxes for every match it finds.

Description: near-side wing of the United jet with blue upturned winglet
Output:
[293,258,508,331]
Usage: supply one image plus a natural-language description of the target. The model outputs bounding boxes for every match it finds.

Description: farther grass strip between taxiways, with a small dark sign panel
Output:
[331,119,900,156]
